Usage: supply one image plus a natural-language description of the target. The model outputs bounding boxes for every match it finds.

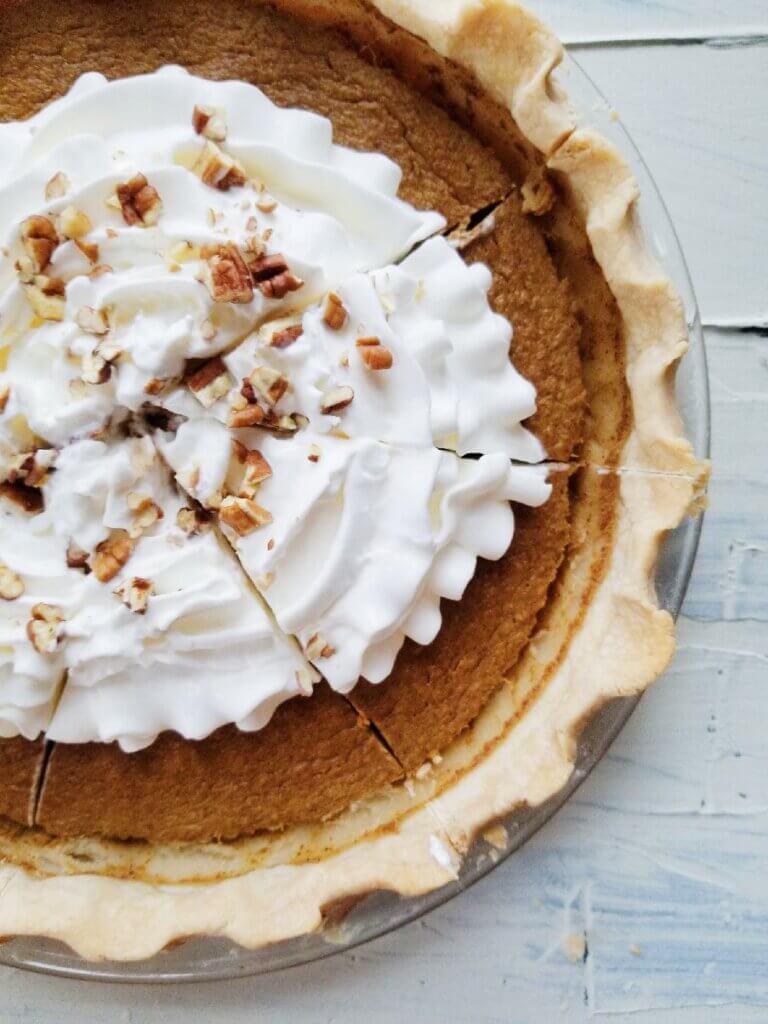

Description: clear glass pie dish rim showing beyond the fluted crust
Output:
[0,54,710,983]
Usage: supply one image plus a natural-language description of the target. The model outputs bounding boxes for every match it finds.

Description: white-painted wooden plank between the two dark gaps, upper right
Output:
[577,41,768,327]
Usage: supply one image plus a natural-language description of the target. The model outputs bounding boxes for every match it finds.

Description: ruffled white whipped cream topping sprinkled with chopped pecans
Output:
[0,68,550,751]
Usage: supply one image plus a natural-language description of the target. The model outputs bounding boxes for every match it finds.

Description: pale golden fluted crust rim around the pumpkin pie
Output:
[0,0,708,959]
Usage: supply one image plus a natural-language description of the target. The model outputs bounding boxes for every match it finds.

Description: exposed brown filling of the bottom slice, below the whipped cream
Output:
[37,685,401,842]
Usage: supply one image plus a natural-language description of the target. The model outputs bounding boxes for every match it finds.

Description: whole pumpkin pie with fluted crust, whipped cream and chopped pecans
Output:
[0,0,706,958]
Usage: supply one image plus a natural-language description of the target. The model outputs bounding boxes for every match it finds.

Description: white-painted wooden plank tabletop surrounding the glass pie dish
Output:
[0,0,768,1024]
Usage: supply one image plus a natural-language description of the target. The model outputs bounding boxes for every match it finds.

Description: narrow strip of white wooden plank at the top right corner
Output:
[526,0,768,43]
